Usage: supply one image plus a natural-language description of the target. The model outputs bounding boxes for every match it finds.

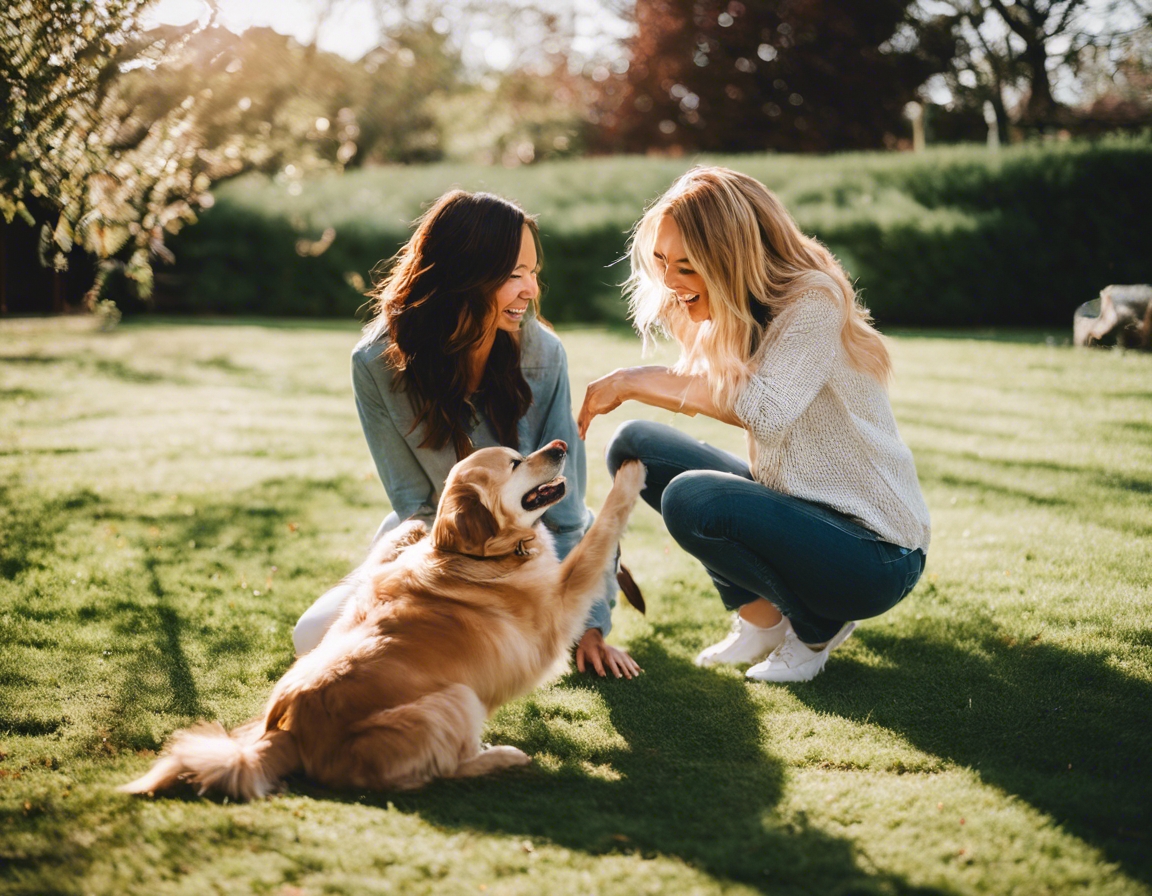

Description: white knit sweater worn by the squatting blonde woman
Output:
[734,288,931,552]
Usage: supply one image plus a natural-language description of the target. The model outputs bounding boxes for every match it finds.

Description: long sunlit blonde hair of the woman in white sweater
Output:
[626,167,892,409]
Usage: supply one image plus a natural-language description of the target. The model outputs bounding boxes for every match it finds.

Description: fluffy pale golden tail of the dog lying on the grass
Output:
[120,720,301,799]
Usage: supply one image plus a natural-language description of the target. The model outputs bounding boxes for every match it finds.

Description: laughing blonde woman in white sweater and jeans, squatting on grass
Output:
[577,167,930,682]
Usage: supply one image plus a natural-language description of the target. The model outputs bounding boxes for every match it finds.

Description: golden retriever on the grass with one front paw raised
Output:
[121,440,644,799]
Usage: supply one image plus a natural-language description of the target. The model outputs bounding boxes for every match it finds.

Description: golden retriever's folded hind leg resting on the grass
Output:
[334,684,528,790]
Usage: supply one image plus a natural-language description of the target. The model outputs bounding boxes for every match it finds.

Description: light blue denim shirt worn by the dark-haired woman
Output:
[353,319,616,635]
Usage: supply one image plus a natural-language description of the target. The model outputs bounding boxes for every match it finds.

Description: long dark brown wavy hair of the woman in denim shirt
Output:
[364,190,541,458]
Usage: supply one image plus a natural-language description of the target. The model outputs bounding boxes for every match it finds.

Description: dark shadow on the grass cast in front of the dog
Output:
[306,639,937,894]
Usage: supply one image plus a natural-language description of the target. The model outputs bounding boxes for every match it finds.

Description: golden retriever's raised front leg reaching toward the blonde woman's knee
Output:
[560,461,646,623]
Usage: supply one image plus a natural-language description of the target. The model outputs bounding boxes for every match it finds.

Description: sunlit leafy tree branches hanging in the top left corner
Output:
[0,0,210,294]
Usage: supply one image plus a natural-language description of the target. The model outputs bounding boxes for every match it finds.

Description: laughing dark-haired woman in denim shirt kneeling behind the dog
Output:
[293,190,641,678]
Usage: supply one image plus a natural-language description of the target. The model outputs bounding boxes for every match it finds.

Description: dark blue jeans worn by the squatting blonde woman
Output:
[608,420,925,644]
